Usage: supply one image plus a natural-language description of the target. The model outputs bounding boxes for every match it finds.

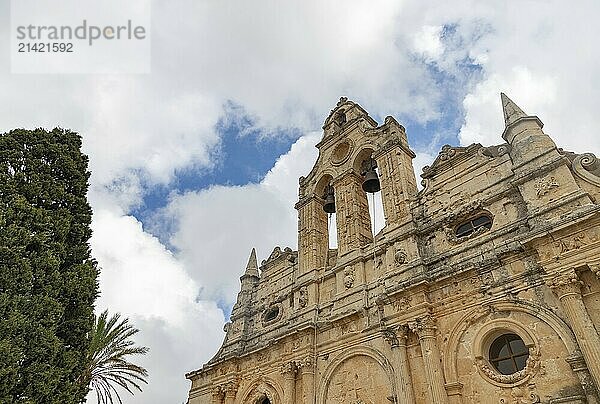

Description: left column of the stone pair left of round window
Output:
[385,325,415,404]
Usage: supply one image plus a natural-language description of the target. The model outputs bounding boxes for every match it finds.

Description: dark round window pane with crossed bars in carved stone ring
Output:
[489,334,529,375]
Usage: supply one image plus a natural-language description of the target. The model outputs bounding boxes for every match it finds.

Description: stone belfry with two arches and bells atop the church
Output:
[296,97,417,275]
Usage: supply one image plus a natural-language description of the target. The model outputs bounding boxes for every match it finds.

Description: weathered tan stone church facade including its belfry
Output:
[186,94,600,404]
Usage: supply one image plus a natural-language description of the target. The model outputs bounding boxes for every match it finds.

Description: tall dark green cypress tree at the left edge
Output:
[0,129,98,404]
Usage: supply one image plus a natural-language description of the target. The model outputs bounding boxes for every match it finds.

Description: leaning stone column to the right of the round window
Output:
[549,270,600,389]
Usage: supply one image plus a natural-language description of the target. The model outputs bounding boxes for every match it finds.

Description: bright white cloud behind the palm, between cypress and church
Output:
[89,210,224,404]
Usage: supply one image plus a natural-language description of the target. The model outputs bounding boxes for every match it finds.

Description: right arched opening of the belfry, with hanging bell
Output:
[353,148,385,237]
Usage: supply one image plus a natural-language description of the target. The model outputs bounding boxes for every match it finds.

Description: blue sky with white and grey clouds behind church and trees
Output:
[0,0,600,404]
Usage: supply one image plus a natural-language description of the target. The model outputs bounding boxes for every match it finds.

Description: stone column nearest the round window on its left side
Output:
[409,315,448,404]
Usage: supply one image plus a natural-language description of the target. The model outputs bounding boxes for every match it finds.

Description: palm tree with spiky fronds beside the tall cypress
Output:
[82,310,148,404]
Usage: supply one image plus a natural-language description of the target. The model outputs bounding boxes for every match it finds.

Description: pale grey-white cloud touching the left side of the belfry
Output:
[158,133,321,302]
